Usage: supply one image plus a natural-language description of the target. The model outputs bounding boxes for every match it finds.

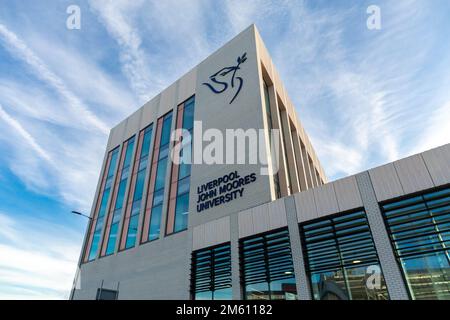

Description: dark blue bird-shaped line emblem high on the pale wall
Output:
[203,52,247,104]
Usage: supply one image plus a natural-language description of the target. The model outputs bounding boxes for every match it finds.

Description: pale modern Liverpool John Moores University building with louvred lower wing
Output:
[71,26,450,300]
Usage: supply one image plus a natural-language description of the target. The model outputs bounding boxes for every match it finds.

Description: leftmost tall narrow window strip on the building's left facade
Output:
[84,148,119,262]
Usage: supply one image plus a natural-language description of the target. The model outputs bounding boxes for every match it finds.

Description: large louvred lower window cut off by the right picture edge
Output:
[382,188,450,300]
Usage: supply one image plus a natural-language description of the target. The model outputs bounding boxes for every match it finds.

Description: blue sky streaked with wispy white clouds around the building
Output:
[0,0,450,299]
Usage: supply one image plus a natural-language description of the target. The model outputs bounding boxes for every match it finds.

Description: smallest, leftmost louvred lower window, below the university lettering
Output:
[191,243,233,300]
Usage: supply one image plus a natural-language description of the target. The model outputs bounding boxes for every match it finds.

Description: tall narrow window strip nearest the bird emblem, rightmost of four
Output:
[166,97,195,234]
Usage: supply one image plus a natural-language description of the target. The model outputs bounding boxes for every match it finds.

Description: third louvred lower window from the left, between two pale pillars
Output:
[300,211,388,300]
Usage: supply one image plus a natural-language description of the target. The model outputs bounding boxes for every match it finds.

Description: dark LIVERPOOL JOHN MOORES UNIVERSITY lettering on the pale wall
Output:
[197,171,256,212]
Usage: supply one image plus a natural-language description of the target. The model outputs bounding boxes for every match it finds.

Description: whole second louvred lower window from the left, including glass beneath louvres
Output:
[240,228,297,300]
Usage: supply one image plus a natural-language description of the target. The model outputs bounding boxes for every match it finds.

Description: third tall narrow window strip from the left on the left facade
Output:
[141,112,172,242]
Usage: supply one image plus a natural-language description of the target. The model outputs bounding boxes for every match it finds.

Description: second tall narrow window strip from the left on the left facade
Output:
[119,125,153,250]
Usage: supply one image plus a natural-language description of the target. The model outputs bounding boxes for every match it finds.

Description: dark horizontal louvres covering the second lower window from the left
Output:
[240,229,294,285]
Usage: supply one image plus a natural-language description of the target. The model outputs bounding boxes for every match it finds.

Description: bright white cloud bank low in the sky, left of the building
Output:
[0,212,81,299]
